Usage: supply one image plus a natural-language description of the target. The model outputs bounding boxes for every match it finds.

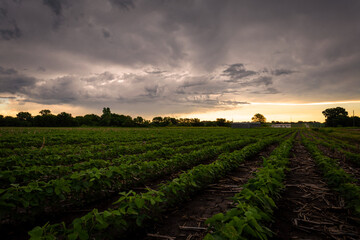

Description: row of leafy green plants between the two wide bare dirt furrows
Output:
[204,133,296,240]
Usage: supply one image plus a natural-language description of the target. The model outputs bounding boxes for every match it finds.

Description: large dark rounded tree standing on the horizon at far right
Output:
[322,107,351,127]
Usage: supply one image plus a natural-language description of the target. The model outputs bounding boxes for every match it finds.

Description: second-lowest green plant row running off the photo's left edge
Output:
[0,136,236,188]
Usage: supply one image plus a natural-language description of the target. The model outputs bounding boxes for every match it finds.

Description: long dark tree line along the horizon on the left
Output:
[0,107,231,127]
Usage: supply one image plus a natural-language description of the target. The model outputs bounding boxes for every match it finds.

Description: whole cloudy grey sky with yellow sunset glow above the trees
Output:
[0,0,360,122]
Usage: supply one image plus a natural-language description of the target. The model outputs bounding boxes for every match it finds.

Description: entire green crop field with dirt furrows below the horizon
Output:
[0,127,360,240]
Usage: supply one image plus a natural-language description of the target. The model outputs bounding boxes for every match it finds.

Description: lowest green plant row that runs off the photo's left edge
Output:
[0,138,255,223]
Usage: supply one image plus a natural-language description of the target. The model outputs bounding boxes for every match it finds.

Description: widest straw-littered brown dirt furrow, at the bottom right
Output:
[270,139,360,239]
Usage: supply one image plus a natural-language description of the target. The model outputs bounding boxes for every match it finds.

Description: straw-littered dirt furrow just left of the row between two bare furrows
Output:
[141,145,276,240]
